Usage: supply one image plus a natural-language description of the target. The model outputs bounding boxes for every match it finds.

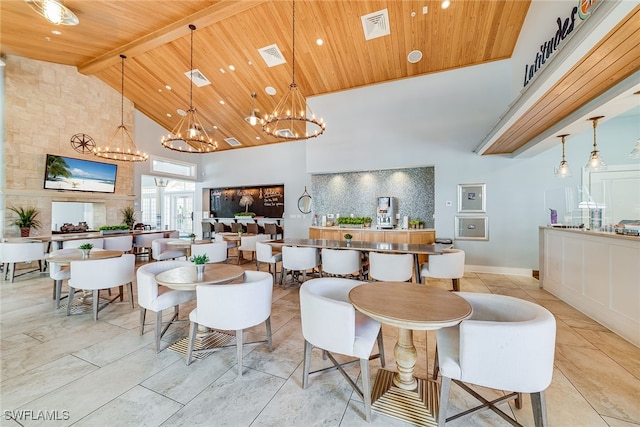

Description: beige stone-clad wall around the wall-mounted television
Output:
[0,56,135,237]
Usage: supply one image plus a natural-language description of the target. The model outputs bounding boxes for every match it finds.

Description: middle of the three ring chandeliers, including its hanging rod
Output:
[162,24,218,154]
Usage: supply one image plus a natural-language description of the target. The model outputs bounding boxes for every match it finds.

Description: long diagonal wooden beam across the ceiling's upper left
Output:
[78,0,267,75]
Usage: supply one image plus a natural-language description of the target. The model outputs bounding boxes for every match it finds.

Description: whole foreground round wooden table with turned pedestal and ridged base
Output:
[349,282,472,426]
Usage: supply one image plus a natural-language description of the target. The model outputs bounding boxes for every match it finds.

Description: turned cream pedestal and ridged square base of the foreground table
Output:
[371,328,439,426]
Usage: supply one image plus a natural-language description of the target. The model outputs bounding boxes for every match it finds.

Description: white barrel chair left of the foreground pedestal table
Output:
[300,277,385,421]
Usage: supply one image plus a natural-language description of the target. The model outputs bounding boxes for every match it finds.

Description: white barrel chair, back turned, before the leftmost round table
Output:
[67,254,136,320]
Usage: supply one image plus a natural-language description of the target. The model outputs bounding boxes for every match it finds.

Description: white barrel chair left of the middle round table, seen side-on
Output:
[136,260,196,353]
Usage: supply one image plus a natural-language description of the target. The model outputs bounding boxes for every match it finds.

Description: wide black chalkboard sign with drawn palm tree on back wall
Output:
[209,184,284,218]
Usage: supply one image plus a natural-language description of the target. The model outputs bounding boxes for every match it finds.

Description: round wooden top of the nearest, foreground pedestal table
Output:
[349,282,472,331]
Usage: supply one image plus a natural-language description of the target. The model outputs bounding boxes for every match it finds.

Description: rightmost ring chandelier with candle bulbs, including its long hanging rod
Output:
[262,0,325,140]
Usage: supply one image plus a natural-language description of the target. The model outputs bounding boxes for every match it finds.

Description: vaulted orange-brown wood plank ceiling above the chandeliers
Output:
[0,0,529,149]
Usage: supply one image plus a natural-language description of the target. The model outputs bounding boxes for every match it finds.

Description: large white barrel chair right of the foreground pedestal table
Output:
[434,292,556,427]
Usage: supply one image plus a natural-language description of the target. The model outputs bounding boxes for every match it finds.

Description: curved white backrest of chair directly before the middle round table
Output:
[196,271,273,331]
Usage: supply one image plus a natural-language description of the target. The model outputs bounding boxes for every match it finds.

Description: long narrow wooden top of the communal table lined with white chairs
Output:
[265,238,442,255]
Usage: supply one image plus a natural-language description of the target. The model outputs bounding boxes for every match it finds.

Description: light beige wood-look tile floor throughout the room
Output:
[0,264,640,427]
